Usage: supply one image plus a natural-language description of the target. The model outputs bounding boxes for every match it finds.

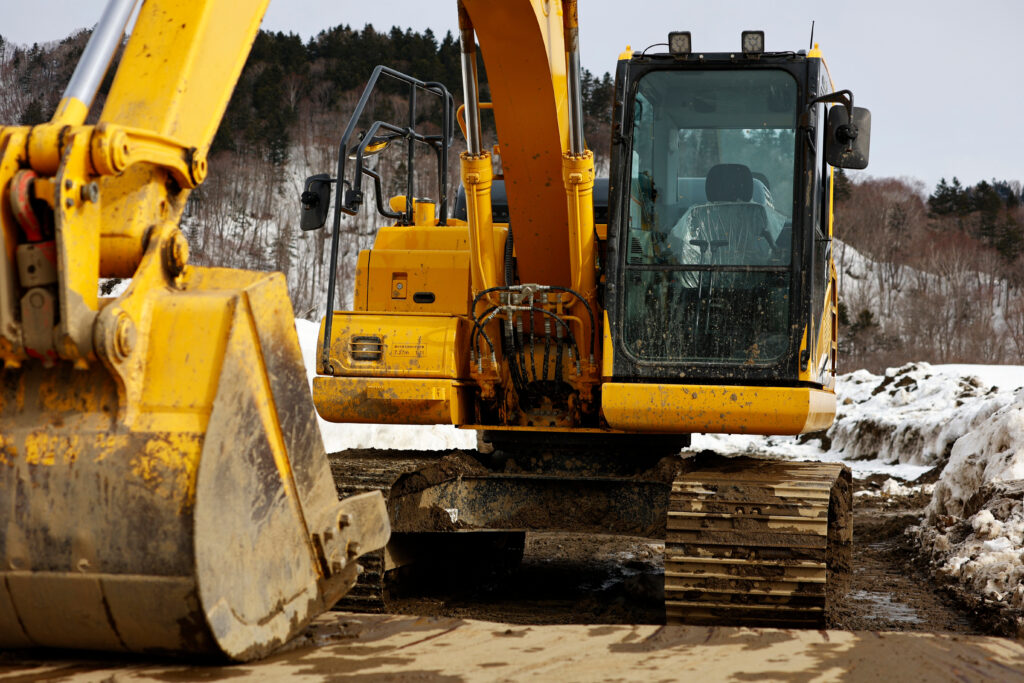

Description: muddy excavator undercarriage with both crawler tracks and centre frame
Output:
[331,431,852,628]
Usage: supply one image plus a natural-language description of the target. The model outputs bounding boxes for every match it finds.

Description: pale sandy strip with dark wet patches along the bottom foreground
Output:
[0,612,1024,682]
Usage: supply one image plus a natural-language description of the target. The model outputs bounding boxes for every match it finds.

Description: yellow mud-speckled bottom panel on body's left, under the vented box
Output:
[313,377,472,425]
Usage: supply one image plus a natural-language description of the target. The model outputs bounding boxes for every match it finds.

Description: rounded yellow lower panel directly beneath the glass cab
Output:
[601,382,836,434]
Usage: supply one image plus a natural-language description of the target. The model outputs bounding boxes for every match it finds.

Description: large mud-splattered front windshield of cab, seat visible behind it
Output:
[624,70,797,365]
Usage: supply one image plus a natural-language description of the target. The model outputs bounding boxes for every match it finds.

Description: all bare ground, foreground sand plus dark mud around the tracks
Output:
[0,480,1024,682]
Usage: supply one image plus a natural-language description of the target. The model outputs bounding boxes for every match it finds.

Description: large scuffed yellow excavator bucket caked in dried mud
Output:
[0,268,388,659]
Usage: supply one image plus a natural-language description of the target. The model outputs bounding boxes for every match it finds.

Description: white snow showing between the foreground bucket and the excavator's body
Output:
[295,318,476,453]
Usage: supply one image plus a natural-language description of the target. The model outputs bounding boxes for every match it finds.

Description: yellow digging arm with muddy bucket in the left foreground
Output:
[0,0,389,659]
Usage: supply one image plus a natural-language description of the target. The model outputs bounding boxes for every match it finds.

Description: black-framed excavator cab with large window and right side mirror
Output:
[604,41,869,433]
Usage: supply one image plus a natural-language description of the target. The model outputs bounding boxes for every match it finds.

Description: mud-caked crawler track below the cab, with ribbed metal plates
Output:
[665,459,851,628]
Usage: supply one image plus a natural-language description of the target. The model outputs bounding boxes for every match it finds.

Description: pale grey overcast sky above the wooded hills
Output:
[0,0,1024,190]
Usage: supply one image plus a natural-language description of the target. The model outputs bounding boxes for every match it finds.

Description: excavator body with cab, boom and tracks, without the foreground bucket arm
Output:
[302,0,870,626]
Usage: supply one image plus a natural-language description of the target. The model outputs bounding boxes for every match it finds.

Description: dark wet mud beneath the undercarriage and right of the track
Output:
[380,478,992,634]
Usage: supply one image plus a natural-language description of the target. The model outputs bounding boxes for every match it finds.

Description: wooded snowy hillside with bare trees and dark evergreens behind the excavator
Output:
[0,26,1024,372]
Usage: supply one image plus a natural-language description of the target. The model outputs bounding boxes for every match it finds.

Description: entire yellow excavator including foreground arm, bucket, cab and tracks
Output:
[0,0,868,659]
